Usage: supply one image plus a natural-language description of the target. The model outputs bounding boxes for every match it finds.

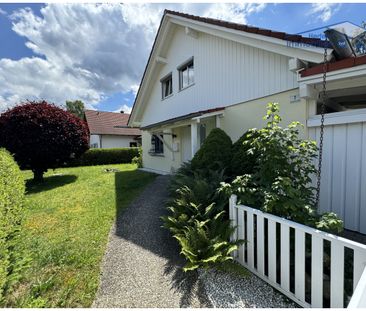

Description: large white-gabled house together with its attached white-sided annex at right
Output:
[128,11,366,233]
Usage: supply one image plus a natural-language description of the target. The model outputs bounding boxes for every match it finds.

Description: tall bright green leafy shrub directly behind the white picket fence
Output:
[221,103,342,231]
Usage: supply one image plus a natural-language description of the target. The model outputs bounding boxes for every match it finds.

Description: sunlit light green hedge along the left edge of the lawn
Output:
[0,149,25,306]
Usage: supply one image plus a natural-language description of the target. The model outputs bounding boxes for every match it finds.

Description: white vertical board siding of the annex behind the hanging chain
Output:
[309,113,366,234]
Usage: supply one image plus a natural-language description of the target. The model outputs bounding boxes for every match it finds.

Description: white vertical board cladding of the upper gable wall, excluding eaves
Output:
[142,27,298,126]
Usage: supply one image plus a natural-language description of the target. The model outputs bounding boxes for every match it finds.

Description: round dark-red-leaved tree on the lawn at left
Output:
[0,101,89,181]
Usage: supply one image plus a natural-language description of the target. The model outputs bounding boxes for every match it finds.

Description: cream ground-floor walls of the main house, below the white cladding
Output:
[142,89,308,173]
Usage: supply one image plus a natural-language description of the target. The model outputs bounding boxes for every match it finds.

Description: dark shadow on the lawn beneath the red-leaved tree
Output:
[25,175,77,194]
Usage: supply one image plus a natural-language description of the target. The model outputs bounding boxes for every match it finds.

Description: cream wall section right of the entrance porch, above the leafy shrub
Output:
[221,89,307,142]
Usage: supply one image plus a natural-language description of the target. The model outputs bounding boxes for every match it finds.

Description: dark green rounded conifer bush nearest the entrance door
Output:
[191,128,232,170]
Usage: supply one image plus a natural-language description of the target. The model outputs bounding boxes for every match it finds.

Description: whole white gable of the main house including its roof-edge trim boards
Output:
[129,11,323,126]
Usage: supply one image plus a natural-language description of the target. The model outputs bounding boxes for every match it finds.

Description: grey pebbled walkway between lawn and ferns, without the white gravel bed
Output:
[93,176,209,308]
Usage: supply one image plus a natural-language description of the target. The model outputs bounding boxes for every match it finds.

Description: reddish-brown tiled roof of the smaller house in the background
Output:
[85,110,141,136]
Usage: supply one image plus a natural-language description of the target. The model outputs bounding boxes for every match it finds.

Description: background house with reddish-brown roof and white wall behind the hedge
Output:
[85,110,141,148]
